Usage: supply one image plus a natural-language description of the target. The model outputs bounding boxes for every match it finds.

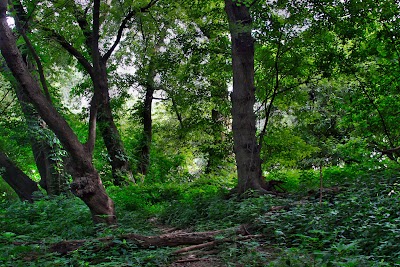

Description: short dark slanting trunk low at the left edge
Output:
[0,152,39,202]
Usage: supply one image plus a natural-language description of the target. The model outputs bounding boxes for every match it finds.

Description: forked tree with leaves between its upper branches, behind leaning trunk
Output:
[28,0,162,185]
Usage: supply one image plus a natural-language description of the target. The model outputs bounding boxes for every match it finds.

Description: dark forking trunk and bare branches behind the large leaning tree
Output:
[37,0,135,185]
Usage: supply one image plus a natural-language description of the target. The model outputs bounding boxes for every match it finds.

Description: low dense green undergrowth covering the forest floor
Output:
[0,168,400,266]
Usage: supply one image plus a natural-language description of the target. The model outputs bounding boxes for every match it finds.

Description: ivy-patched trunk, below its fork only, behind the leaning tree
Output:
[94,62,135,186]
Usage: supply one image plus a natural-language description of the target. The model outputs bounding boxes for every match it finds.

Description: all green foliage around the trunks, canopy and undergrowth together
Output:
[0,0,400,266]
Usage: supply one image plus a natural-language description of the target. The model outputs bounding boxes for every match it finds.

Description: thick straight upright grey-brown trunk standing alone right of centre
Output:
[225,0,265,193]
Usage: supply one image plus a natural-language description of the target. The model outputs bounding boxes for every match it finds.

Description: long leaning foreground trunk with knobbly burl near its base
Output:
[0,0,116,224]
